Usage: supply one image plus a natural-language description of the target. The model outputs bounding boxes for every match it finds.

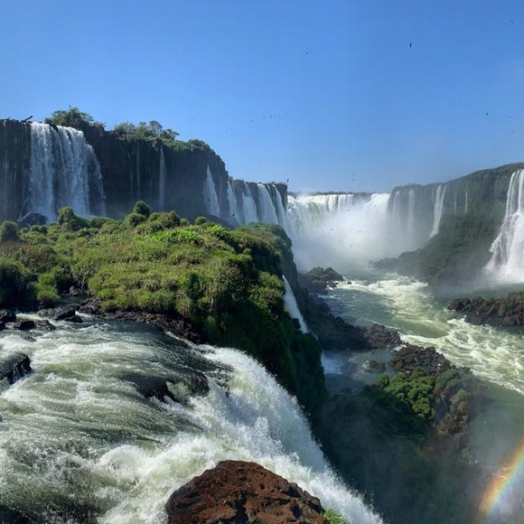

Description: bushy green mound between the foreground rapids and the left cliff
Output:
[0,207,326,420]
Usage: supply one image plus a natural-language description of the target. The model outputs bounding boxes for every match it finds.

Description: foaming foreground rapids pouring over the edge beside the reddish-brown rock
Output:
[0,318,381,524]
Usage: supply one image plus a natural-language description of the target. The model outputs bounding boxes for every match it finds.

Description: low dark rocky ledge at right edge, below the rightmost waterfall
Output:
[448,292,524,327]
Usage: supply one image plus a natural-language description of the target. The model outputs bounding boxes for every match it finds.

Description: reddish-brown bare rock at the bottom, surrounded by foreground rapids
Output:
[166,460,327,524]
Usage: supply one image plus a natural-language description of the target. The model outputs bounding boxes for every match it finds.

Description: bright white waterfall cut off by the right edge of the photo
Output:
[486,169,524,282]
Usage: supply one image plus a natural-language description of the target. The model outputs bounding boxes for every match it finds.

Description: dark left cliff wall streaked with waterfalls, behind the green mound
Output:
[0,120,287,225]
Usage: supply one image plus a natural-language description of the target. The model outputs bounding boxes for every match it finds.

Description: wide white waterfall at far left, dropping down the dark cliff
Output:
[26,122,105,221]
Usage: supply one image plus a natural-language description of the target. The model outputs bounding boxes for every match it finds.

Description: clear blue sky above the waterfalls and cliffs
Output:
[0,0,524,191]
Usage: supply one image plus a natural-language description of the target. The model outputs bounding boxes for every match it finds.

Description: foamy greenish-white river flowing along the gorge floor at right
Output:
[334,274,524,394]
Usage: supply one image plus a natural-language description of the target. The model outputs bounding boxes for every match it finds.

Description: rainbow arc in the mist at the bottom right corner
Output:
[475,439,524,524]
